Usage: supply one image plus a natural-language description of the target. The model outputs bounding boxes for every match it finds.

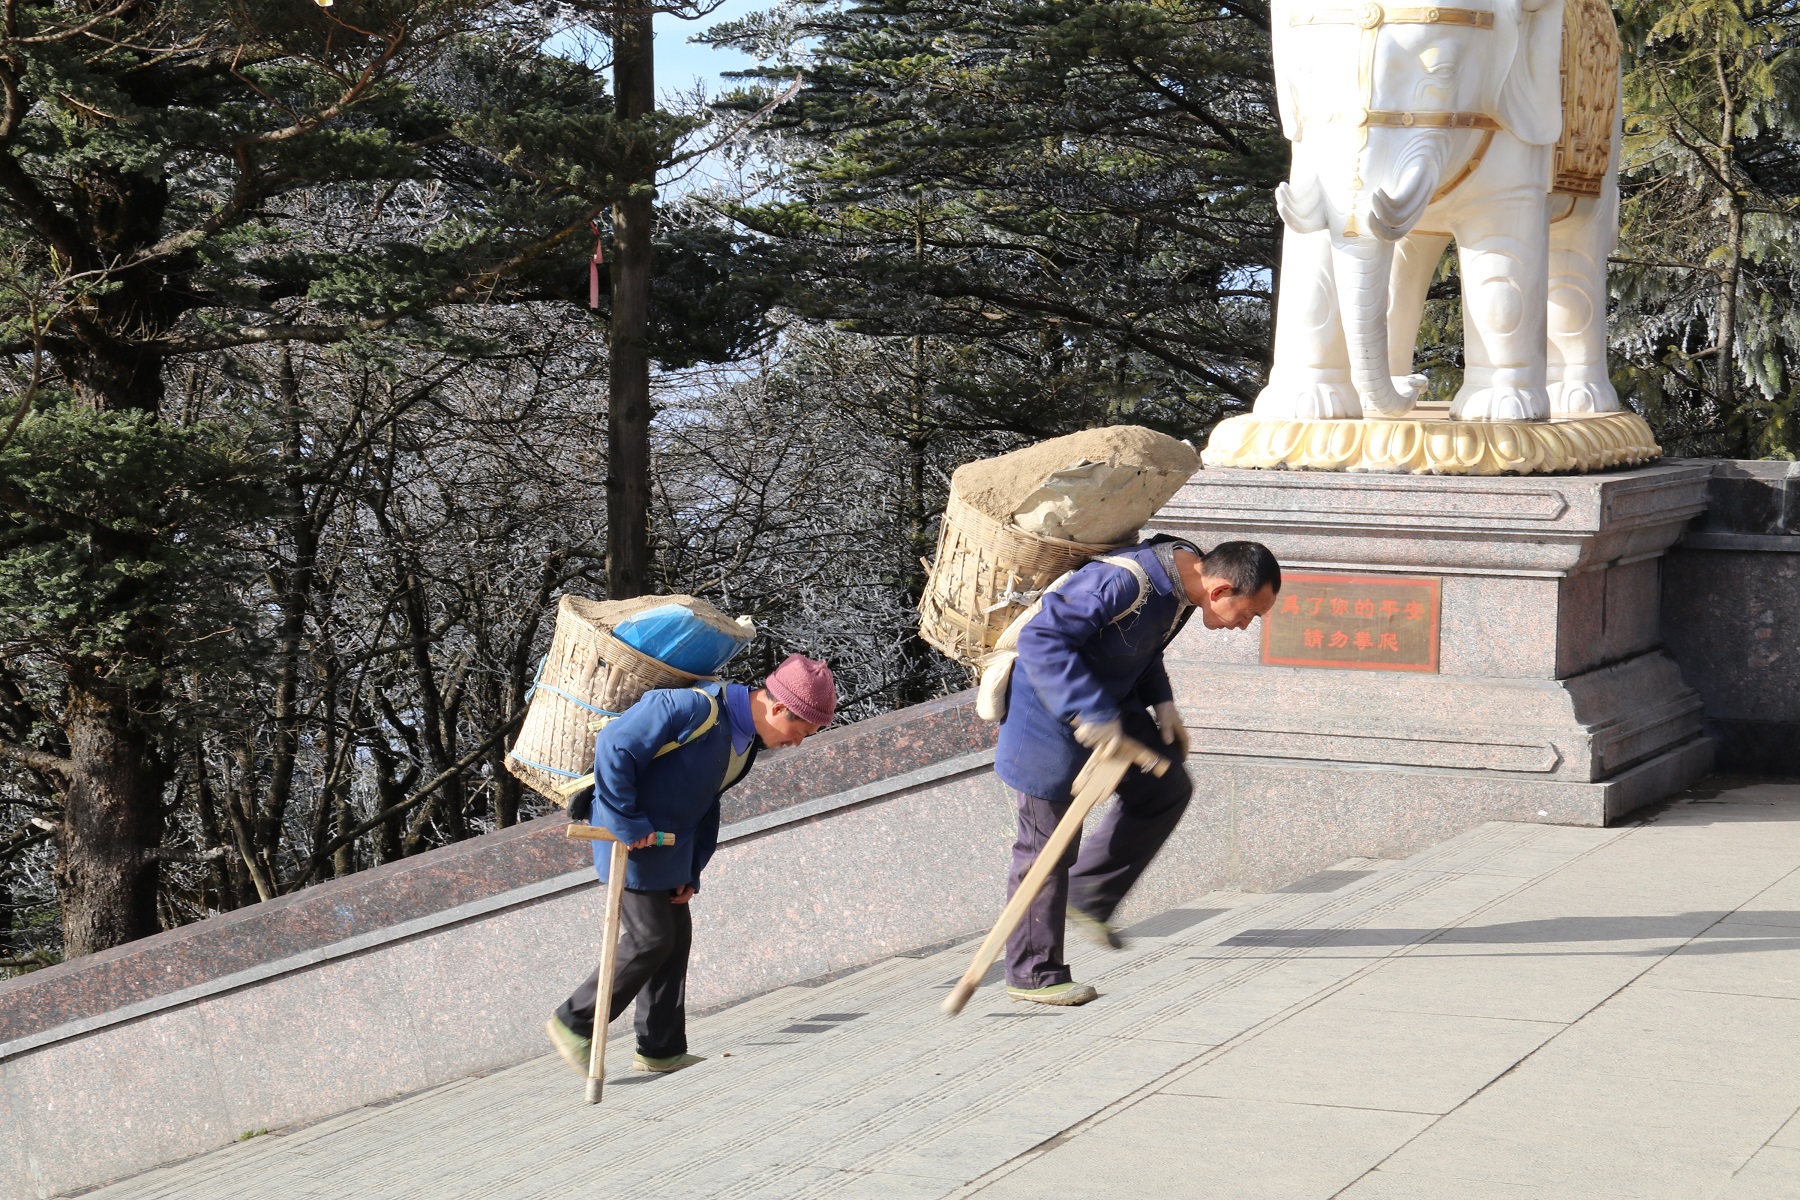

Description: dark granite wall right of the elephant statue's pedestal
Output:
[1663,459,1800,775]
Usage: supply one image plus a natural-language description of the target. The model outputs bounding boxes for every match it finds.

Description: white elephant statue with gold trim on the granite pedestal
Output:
[1255,0,1620,421]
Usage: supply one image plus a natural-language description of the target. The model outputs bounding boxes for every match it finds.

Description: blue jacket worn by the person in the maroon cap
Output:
[590,684,756,891]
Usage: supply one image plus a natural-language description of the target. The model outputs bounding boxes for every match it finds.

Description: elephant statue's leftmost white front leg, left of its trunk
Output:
[1256,228,1363,421]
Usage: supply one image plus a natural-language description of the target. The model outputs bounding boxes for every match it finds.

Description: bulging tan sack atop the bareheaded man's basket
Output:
[950,425,1201,545]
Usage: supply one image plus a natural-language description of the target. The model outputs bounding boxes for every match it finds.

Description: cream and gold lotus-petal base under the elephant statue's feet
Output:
[1201,405,1661,475]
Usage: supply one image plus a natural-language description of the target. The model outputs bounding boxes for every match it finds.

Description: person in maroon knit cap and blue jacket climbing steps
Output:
[545,655,837,1074]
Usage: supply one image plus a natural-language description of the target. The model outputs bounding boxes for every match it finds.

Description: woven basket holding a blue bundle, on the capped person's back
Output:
[506,596,713,804]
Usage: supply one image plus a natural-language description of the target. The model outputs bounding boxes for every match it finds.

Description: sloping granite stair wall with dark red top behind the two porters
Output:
[0,694,1012,1200]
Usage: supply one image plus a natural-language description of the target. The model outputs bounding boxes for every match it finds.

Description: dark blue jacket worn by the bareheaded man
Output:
[994,543,1188,804]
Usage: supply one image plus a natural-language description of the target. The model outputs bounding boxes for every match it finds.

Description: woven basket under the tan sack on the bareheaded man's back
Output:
[918,489,1118,667]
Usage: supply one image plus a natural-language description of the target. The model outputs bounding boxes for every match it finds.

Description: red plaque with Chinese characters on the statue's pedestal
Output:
[1262,572,1438,673]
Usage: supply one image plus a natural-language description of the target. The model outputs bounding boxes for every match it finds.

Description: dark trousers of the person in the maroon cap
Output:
[556,889,693,1058]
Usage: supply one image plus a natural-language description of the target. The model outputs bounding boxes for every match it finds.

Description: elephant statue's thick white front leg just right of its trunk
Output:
[1451,189,1550,421]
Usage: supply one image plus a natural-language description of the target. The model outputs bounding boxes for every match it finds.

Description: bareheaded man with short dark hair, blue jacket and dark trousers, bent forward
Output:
[994,538,1282,1004]
